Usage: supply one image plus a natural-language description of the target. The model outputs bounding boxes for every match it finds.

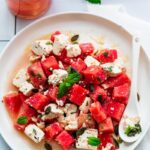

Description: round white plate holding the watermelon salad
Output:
[0,13,150,150]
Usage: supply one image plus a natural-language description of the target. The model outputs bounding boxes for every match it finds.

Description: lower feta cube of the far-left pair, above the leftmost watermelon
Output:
[19,81,34,95]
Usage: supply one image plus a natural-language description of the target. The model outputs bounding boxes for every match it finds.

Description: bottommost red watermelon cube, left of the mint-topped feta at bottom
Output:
[56,131,75,150]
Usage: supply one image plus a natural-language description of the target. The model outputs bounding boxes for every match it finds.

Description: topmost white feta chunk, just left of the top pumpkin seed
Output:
[53,34,69,55]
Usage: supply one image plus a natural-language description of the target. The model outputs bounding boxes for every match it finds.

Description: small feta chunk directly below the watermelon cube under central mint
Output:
[64,103,77,116]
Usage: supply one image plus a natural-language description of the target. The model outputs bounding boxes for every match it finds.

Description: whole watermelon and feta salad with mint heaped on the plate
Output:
[3,31,136,150]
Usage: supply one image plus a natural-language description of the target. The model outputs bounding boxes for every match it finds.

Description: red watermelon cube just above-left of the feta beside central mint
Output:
[41,56,59,76]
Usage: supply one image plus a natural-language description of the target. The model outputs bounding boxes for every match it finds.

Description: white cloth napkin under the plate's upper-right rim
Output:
[87,4,150,150]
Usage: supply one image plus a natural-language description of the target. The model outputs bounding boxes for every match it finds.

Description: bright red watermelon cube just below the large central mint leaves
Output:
[70,84,88,105]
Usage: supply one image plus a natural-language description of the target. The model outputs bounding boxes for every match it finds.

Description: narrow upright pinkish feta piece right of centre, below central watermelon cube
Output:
[79,97,91,113]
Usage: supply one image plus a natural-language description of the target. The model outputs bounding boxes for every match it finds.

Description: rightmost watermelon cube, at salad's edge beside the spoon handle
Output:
[113,83,130,104]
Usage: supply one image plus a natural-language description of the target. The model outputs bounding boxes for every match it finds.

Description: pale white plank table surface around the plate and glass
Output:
[0,0,150,150]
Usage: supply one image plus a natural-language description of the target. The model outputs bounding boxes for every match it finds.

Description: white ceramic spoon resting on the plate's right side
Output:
[119,38,140,143]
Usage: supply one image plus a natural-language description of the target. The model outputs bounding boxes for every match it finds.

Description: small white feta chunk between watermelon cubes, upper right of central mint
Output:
[84,56,100,67]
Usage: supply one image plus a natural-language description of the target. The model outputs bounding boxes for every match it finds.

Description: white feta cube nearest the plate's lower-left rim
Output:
[24,124,44,143]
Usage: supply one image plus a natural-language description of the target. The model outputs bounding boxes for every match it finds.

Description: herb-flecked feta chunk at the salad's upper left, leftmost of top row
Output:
[32,40,53,56]
